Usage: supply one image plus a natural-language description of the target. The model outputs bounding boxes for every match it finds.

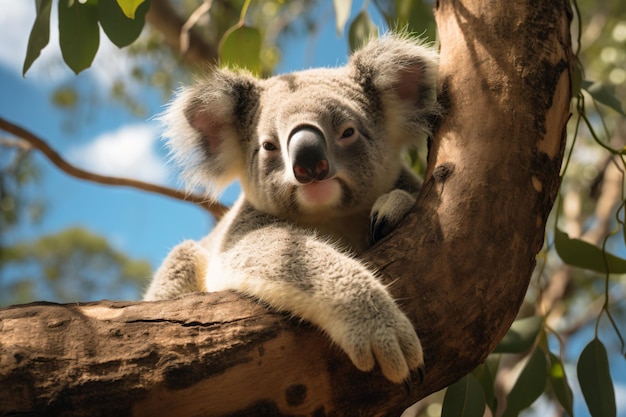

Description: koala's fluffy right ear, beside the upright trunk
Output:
[348,34,440,145]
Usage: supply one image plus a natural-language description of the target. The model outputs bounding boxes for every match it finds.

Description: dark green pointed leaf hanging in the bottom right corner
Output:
[577,339,617,417]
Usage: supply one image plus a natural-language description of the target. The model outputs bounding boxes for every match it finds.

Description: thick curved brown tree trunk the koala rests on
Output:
[0,0,573,416]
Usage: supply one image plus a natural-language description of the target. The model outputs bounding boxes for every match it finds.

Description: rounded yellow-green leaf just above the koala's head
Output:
[220,26,261,76]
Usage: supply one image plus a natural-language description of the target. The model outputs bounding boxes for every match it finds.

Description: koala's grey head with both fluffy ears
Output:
[163,35,438,223]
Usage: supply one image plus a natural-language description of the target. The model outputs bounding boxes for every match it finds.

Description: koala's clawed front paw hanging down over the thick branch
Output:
[336,290,424,383]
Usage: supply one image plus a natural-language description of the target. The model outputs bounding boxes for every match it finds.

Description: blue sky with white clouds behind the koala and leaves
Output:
[0,0,626,416]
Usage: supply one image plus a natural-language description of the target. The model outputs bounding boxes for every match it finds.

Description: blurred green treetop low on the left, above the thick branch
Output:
[0,227,152,305]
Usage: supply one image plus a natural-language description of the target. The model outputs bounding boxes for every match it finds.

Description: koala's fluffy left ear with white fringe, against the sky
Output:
[160,68,260,197]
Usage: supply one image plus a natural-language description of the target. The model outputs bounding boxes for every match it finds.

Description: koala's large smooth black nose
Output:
[287,126,329,184]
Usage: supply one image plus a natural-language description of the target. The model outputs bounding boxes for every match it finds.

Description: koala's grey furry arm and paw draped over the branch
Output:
[212,218,424,383]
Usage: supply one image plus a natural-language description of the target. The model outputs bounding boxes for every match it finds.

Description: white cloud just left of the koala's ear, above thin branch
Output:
[69,124,169,184]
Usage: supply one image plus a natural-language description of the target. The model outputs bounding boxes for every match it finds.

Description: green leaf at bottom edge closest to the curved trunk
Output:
[441,374,485,417]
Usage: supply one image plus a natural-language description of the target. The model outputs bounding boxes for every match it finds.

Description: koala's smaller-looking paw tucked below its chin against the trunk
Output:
[369,189,415,244]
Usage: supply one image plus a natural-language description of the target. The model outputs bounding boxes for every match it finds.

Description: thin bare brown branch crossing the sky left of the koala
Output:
[0,117,228,220]
